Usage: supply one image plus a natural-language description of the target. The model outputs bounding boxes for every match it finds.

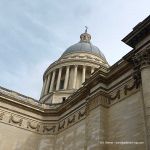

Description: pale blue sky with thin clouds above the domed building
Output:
[0,0,150,99]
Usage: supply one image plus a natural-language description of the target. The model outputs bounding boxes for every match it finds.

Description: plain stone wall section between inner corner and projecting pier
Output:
[54,120,86,150]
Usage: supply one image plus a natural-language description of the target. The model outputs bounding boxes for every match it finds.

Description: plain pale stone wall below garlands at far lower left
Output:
[0,123,41,150]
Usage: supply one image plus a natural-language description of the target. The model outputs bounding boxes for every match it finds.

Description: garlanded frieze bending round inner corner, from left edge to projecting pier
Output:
[0,107,86,134]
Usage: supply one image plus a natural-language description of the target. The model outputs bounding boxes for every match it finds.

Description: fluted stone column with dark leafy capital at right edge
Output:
[132,47,150,150]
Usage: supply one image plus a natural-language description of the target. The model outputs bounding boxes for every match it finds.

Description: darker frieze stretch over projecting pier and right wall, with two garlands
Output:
[86,76,139,108]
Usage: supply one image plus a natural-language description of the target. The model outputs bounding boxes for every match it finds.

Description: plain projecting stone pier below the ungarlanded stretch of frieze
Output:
[86,106,107,150]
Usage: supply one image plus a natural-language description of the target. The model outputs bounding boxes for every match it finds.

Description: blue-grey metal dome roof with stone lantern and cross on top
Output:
[62,29,106,61]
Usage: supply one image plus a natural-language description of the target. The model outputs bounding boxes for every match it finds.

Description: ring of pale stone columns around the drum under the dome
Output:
[41,65,96,96]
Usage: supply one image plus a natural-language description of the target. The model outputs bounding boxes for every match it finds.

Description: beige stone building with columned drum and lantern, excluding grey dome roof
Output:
[0,16,150,150]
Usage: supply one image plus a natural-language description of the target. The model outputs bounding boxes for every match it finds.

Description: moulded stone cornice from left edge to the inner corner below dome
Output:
[0,87,58,114]
